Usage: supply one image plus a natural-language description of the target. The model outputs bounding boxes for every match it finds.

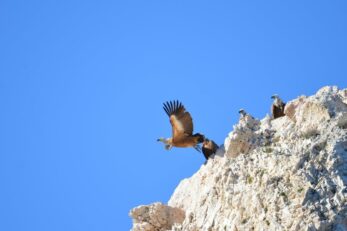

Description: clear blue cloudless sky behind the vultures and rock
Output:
[0,0,347,231]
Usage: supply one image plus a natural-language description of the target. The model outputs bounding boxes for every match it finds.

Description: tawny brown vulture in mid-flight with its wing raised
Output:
[158,100,205,152]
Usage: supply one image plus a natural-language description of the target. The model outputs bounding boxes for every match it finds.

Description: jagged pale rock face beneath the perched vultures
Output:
[131,87,347,231]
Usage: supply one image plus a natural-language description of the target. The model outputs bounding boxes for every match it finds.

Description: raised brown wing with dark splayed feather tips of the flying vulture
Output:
[163,100,193,139]
